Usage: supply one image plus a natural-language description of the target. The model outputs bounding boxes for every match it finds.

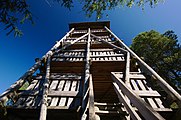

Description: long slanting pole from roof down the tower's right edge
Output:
[105,26,181,107]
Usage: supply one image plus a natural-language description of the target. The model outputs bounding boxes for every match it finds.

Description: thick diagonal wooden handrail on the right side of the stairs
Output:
[111,73,164,120]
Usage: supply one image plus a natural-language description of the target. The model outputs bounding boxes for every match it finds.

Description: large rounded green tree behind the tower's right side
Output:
[131,30,181,90]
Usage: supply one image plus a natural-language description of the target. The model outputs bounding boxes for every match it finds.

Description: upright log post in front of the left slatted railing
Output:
[39,55,51,120]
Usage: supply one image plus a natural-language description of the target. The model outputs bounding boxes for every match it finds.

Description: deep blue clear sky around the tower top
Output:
[0,0,181,93]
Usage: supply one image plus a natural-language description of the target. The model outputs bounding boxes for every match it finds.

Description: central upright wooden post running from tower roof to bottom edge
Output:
[82,28,90,120]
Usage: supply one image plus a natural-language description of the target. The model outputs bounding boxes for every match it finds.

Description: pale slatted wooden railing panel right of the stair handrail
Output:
[115,72,172,114]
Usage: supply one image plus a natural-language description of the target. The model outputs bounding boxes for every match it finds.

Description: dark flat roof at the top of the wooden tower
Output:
[69,21,110,30]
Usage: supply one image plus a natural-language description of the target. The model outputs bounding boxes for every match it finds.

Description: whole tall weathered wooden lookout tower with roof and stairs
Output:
[0,21,181,120]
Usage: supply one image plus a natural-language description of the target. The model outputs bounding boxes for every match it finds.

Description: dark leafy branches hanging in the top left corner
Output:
[0,0,33,36]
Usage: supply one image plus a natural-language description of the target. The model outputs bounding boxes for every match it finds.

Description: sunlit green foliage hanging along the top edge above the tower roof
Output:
[54,0,163,19]
